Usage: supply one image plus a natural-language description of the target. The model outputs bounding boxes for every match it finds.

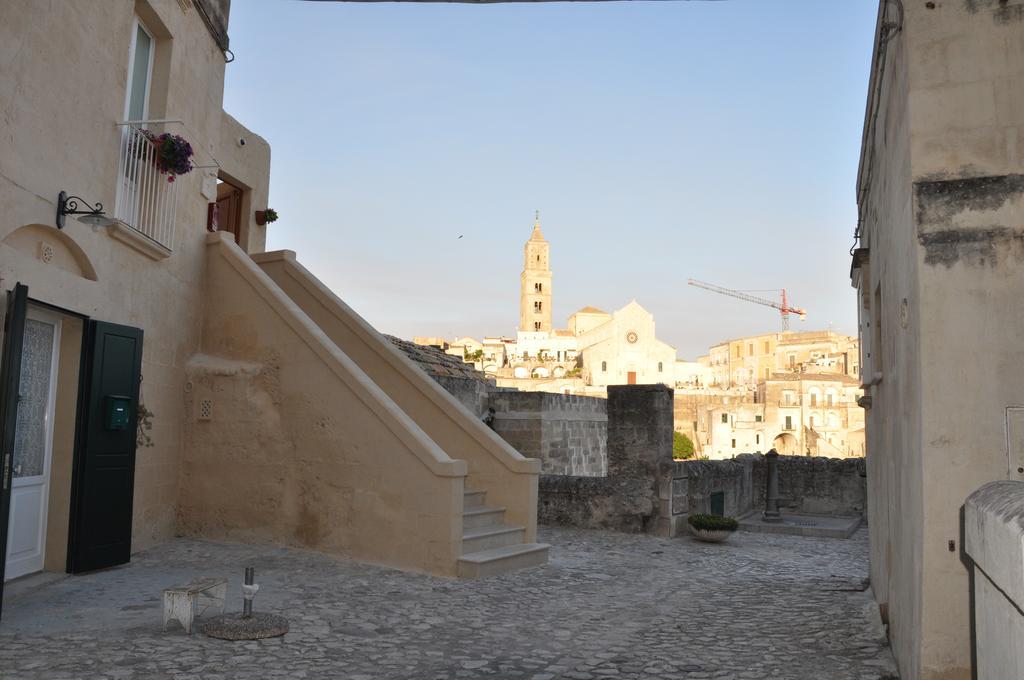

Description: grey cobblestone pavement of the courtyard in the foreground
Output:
[0,528,895,680]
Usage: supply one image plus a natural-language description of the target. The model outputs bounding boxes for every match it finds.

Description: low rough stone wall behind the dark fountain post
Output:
[675,454,867,517]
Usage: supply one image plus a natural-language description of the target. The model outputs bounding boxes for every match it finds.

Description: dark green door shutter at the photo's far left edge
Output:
[0,284,29,608]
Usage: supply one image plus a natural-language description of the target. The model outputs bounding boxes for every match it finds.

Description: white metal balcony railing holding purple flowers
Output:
[114,121,180,250]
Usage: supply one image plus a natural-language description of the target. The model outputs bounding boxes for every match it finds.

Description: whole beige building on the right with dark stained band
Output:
[851,0,1024,680]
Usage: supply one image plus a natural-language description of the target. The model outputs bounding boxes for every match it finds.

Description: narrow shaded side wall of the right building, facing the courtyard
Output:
[858,3,923,678]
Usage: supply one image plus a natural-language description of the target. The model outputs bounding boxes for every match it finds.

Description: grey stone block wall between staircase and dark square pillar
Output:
[489,391,608,477]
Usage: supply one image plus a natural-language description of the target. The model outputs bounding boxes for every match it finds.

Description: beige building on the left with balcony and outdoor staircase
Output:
[0,0,546,610]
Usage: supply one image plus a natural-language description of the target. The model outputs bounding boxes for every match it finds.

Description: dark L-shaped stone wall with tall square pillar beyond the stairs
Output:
[538,385,676,536]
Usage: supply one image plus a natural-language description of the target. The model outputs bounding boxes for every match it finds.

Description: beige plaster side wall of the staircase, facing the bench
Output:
[179,233,467,575]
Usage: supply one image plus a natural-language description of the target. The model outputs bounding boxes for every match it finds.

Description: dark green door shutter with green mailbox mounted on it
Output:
[68,321,142,572]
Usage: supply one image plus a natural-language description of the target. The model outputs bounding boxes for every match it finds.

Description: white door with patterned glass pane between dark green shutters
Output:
[4,307,60,581]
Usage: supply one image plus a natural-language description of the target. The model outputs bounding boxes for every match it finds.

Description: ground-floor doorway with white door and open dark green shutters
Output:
[0,284,142,618]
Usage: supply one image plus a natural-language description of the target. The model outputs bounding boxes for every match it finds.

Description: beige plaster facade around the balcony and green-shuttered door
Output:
[0,0,266,566]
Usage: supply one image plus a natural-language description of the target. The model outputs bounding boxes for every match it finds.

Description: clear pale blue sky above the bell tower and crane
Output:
[224,0,878,358]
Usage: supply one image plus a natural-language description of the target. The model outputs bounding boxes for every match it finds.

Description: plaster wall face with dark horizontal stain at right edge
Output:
[909,0,1024,680]
